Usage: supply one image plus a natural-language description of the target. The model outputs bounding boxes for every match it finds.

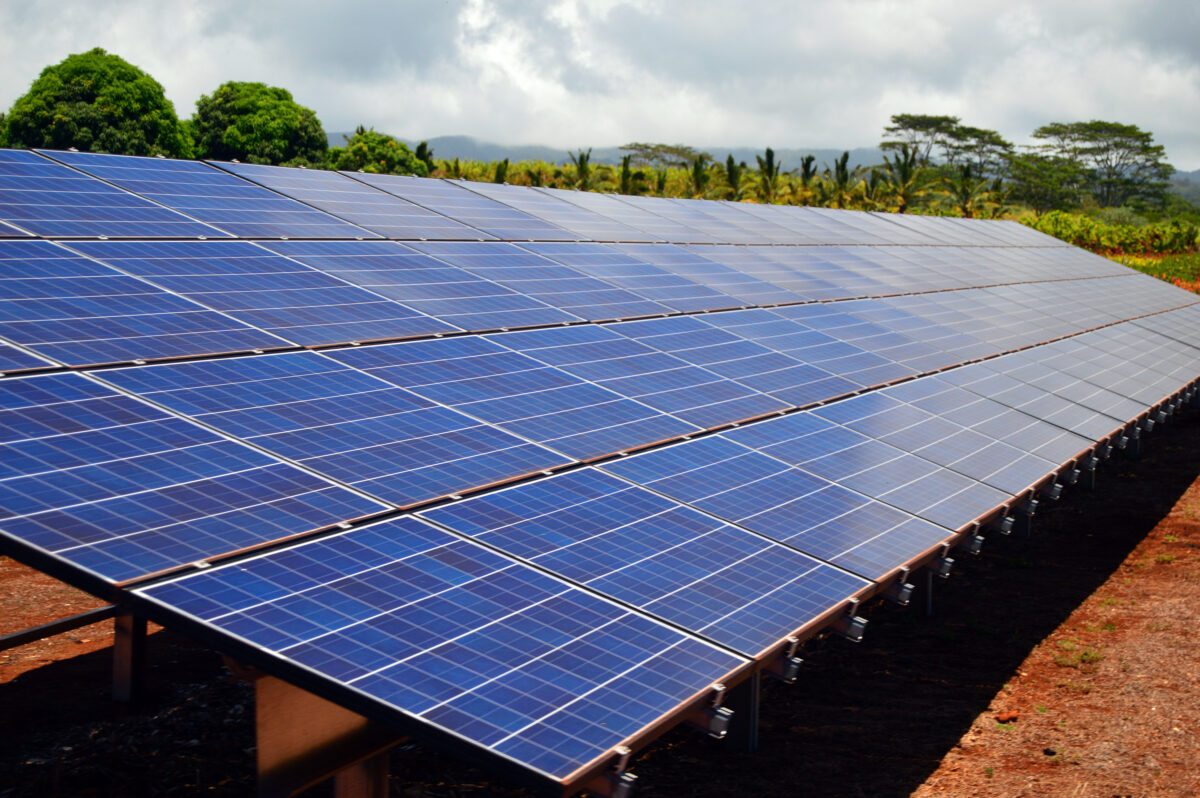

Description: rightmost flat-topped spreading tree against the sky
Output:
[1033,119,1175,208]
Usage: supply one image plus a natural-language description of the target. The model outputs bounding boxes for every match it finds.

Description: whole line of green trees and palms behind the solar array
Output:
[0,48,1182,224]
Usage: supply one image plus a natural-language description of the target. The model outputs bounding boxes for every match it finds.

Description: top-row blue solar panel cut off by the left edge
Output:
[0,150,227,238]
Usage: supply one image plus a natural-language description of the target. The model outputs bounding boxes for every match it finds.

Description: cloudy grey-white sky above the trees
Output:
[0,0,1200,170]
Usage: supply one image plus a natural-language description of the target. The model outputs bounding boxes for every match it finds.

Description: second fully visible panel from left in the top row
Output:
[210,161,492,241]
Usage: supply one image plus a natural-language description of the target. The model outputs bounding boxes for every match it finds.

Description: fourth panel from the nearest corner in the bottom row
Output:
[721,412,1012,529]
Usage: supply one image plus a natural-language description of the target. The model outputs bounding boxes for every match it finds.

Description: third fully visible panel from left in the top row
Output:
[342,172,580,241]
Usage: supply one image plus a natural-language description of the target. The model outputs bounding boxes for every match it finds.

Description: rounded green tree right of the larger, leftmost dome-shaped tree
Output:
[192,80,331,163]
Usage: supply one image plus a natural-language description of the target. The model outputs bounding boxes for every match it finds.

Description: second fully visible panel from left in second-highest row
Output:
[262,241,580,331]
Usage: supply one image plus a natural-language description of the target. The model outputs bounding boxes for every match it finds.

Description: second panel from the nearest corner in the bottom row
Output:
[421,468,868,656]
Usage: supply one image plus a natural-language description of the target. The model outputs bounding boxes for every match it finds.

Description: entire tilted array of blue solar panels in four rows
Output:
[0,151,1200,787]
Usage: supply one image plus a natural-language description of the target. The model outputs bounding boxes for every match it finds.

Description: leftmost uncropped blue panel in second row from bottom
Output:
[104,348,568,506]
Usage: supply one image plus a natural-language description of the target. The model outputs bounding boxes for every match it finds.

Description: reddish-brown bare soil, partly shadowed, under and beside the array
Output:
[0,416,1200,798]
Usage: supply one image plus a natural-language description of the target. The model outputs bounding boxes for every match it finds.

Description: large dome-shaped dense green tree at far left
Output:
[0,47,192,158]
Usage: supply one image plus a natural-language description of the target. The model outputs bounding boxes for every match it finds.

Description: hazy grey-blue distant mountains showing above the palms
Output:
[329,132,883,170]
